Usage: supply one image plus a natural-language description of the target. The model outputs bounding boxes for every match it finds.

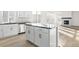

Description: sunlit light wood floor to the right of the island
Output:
[58,27,79,47]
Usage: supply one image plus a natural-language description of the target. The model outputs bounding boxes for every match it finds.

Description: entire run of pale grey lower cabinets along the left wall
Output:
[0,24,19,38]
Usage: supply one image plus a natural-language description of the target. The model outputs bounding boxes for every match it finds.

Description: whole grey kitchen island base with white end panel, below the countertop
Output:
[26,25,57,47]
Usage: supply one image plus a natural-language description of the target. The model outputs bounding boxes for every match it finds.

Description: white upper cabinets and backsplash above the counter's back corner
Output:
[16,11,32,22]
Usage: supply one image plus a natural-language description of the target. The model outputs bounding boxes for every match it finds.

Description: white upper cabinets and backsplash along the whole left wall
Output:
[0,11,33,23]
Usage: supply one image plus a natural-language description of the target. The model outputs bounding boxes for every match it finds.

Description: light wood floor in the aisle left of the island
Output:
[0,34,35,47]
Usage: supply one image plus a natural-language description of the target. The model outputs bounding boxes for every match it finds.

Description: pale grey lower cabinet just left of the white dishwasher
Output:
[3,24,19,37]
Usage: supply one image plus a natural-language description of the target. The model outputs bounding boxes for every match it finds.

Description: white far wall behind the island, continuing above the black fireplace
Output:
[40,11,72,25]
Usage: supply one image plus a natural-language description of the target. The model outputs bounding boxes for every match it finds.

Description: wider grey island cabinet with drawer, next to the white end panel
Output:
[35,27,49,47]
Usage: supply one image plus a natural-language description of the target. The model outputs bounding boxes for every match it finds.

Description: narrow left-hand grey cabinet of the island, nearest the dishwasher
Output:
[26,26,34,43]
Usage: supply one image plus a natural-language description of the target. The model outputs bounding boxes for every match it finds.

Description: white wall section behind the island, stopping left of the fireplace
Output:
[40,11,61,25]
